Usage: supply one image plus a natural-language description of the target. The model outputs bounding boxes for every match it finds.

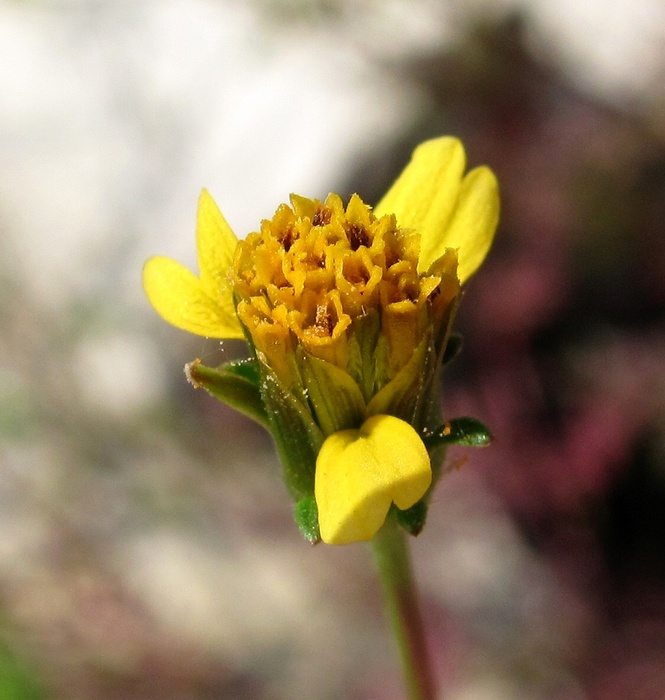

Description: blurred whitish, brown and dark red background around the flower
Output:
[0,0,665,700]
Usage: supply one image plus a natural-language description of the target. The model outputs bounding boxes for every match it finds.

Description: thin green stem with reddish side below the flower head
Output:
[372,517,436,700]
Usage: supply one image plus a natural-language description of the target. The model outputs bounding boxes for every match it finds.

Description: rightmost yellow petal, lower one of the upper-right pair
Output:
[419,166,499,284]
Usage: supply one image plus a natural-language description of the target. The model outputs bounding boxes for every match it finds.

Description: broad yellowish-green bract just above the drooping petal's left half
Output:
[296,348,365,436]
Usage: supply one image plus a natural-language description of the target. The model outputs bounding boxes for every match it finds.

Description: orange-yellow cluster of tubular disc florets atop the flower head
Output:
[233,194,459,388]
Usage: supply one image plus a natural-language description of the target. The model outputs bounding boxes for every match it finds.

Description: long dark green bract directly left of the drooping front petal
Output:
[259,356,323,501]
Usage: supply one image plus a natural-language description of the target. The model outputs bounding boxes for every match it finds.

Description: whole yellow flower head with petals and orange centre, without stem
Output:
[143,137,499,544]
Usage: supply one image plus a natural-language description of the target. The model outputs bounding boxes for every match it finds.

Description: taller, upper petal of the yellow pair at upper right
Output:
[374,136,466,252]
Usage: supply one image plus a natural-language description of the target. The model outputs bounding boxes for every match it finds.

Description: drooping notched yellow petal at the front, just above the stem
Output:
[314,415,432,544]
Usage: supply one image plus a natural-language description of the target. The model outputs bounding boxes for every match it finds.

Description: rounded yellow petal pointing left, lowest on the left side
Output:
[143,257,243,339]
